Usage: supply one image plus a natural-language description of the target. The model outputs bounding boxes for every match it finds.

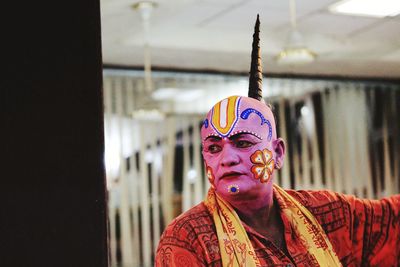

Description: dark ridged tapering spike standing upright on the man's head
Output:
[248,14,262,101]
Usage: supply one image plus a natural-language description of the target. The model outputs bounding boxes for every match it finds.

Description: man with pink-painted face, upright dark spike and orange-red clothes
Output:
[156,17,400,266]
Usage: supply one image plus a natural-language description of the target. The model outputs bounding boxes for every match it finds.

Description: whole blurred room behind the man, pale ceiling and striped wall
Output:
[101,0,400,267]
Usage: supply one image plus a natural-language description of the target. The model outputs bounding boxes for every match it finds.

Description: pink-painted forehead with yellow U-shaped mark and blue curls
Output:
[201,96,274,141]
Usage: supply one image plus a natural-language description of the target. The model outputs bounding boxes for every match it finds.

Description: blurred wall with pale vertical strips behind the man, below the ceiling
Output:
[104,70,400,266]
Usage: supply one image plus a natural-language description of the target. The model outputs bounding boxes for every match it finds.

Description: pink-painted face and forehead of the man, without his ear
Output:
[201,96,276,201]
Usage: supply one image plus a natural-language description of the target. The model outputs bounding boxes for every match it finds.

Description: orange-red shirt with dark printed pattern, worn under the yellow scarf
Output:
[155,190,400,267]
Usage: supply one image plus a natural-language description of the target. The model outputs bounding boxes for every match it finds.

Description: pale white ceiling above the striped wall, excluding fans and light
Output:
[101,0,400,79]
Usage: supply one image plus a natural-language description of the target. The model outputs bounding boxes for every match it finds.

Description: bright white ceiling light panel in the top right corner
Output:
[329,0,400,18]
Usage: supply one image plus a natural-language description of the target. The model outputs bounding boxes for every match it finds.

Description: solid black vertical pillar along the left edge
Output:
[0,0,108,267]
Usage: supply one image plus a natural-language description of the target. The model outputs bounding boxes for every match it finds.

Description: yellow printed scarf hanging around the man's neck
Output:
[204,185,342,267]
